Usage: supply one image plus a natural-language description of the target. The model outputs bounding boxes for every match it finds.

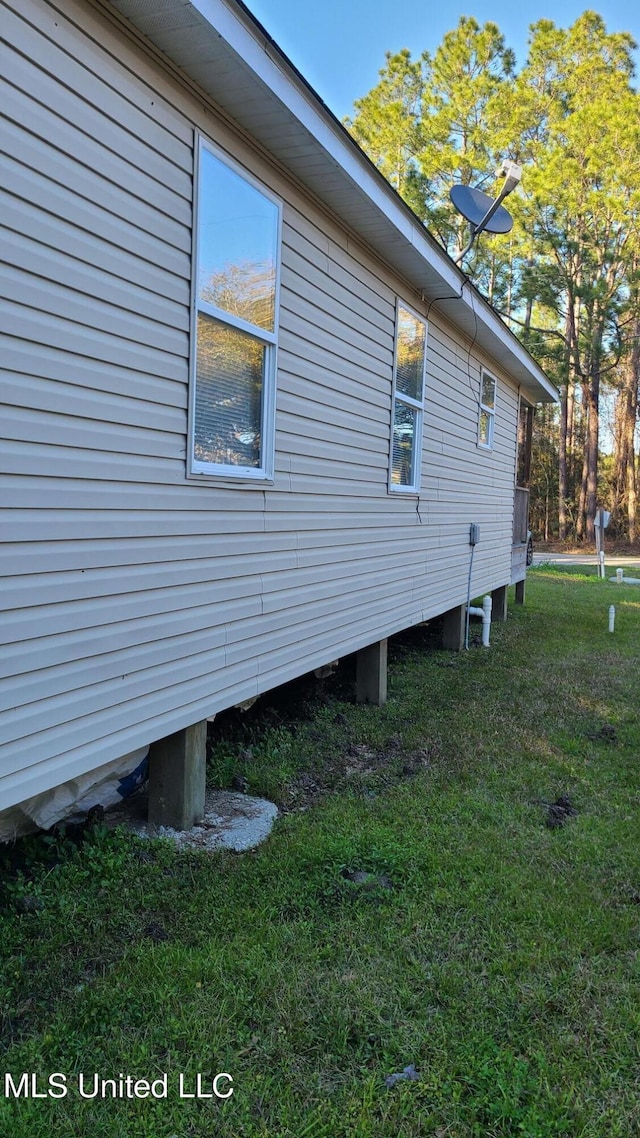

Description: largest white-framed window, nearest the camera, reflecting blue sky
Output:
[189,138,281,479]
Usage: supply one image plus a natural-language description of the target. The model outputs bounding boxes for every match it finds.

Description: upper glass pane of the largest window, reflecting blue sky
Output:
[198,148,278,332]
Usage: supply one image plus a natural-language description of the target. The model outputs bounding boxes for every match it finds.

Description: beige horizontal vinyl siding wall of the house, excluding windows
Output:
[0,0,518,809]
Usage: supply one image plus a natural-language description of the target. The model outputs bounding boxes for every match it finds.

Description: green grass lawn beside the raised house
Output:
[0,567,640,1138]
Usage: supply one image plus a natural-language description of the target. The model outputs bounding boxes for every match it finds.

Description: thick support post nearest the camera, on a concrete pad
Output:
[148,719,206,830]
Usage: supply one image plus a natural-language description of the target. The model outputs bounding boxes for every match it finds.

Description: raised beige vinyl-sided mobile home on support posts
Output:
[0,0,555,820]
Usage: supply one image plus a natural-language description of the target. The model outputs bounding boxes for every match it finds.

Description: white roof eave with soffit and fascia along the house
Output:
[110,0,557,402]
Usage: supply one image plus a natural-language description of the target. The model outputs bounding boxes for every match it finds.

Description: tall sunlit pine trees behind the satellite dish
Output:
[347,11,640,539]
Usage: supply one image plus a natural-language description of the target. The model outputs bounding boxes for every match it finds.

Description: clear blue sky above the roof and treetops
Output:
[246,0,640,118]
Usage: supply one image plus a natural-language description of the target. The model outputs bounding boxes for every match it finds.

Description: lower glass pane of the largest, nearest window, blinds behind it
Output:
[195,313,268,468]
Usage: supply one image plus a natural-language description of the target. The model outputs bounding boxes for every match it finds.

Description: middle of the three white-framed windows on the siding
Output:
[389,300,427,490]
